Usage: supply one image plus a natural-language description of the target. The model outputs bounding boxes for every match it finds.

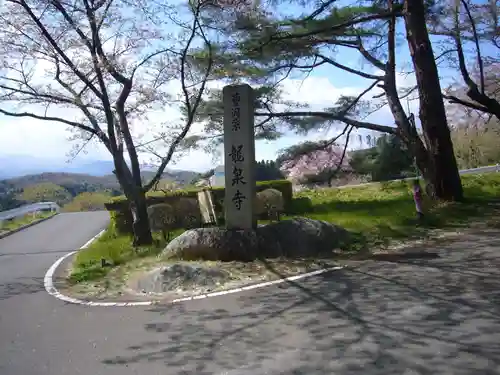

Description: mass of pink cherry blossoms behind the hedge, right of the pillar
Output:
[281,144,350,182]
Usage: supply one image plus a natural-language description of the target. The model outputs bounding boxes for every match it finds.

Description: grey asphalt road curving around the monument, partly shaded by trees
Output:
[0,213,500,375]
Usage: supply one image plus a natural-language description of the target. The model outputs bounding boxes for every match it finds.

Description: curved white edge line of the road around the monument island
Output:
[43,229,345,307]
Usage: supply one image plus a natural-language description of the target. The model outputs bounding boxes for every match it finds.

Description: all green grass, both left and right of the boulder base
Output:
[69,173,500,283]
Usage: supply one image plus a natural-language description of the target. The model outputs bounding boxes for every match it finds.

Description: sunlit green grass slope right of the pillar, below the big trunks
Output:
[297,173,500,247]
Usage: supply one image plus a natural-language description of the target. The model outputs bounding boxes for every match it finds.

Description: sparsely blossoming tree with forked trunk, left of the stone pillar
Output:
[0,0,212,245]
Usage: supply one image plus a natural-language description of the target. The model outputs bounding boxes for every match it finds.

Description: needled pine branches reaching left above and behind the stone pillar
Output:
[188,2,402,153]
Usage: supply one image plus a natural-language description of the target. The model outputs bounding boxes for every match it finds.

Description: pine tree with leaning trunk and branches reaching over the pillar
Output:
[190,0,461,199]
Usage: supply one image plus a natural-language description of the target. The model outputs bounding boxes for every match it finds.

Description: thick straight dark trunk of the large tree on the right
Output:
[404,0,463,201]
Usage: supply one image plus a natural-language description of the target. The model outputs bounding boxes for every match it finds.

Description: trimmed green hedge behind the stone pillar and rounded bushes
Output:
[105,180,293,234]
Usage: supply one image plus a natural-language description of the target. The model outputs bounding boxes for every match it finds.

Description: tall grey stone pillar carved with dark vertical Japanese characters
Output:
[222,85,257,229]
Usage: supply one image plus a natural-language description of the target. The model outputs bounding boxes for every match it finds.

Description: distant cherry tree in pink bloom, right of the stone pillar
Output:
[278,142,350,186]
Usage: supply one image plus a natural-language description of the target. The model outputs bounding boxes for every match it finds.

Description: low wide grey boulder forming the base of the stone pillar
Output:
[162,217,349,262]
